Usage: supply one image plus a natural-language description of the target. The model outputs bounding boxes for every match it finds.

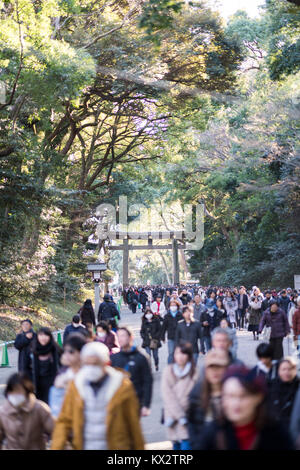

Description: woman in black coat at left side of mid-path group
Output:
[140,307,161,371]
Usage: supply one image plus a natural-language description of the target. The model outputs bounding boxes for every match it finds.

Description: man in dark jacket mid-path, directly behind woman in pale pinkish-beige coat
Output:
[175,306,201,364]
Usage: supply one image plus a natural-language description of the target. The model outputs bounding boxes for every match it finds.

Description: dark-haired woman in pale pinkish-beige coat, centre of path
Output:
[161,343,199,450]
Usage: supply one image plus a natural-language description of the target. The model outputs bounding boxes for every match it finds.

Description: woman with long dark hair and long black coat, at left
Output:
[30,327,62,403]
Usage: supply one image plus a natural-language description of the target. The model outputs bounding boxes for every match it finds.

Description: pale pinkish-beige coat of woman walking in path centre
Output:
[161,364,199,441]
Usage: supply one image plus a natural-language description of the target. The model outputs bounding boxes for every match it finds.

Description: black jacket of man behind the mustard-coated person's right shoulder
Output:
[111,346,153,408]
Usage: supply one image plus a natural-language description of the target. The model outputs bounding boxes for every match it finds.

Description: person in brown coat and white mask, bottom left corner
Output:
[0,372,54,450]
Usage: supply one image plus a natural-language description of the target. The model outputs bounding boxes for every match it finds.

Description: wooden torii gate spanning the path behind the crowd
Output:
[107,230,186,288]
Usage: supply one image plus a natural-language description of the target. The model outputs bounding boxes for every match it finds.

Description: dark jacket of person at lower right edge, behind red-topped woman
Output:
[268,377,299,429]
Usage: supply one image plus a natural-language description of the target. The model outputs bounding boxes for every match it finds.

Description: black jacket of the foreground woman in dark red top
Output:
[196,421,294,451]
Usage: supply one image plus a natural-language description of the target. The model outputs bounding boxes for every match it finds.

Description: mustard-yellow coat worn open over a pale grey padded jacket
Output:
[51,367,144,450]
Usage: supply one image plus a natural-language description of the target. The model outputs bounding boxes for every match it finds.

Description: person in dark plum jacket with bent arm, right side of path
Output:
[259,300,290,359]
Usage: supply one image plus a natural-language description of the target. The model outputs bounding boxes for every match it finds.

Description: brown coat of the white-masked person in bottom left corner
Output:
[0,394,54,450]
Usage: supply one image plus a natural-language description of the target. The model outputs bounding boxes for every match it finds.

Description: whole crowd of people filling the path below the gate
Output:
[0,285,300,451]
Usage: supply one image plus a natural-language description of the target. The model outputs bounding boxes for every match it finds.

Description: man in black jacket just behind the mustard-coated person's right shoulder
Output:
[111,327,153,416]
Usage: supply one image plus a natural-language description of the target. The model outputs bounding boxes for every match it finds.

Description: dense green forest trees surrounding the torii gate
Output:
[0,0,300,305]
